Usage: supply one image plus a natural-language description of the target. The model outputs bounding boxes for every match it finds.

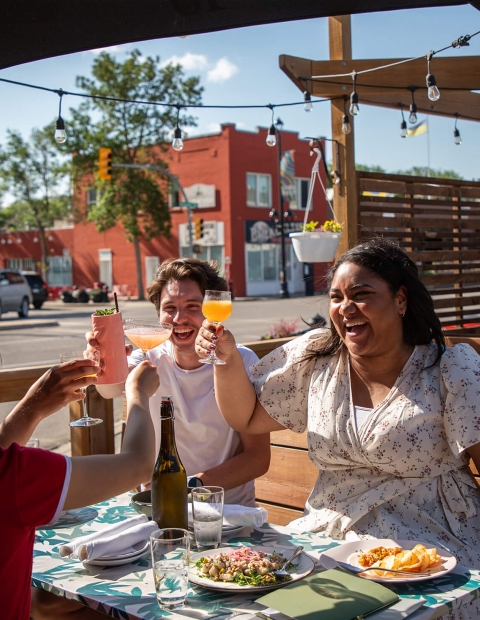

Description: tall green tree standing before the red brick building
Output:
[67,50,203,299]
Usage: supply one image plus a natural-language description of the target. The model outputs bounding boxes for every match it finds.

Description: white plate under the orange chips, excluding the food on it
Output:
[320,538,457,583]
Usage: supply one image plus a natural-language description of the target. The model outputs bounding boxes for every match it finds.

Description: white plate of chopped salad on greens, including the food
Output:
[188,547,315,592]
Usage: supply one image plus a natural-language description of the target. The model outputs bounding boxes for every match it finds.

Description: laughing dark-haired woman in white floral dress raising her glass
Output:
[197,239,480,618]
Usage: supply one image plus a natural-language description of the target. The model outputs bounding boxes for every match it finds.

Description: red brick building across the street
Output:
[0,124,327,296]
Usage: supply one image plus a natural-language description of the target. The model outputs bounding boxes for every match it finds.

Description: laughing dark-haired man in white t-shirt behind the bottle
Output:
[93,258,270,506]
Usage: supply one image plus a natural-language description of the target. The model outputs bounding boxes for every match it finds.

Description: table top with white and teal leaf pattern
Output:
[32,493,480,620]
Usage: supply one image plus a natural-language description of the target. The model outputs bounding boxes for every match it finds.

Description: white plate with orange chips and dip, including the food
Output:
[320,538,457,583]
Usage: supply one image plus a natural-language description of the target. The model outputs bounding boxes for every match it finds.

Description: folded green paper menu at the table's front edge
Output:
[256,568,399,620]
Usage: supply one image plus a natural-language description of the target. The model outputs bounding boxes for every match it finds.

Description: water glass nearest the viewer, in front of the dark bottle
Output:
[150,528,190,611]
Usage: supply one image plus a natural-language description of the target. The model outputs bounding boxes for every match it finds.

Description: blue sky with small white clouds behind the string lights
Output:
[0,5,480,184]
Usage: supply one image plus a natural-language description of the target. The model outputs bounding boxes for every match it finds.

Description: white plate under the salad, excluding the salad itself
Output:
[188,547,315,592]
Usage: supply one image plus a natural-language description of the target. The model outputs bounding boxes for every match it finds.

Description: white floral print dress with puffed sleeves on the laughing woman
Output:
[252,330,480,618]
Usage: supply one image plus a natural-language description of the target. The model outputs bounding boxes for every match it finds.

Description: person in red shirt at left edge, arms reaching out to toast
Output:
[0,359,159,620]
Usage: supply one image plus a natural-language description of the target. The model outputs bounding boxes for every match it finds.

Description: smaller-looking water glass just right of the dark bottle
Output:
[192,487,224,549]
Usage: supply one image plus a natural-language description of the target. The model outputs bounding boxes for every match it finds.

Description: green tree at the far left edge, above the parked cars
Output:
[0,127,69,273]
